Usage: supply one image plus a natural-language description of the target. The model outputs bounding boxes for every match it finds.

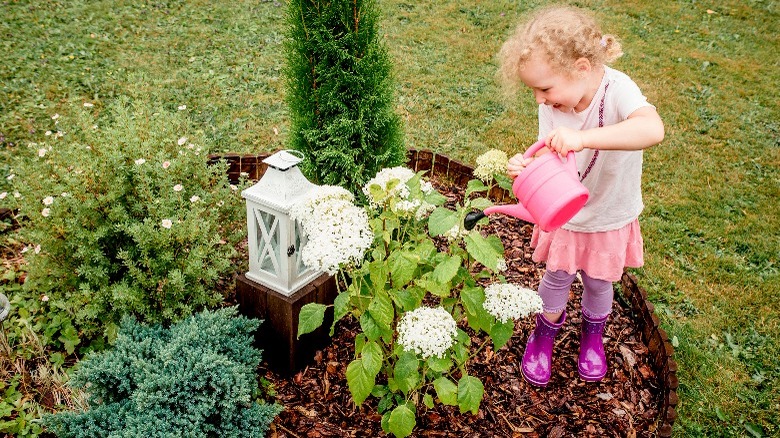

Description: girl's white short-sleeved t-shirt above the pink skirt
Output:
[539,66,652,233]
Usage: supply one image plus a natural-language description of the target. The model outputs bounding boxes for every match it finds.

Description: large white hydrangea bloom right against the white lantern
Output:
[290,186,374,275]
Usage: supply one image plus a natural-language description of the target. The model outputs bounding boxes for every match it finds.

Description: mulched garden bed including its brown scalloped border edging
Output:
[214,151,677,437]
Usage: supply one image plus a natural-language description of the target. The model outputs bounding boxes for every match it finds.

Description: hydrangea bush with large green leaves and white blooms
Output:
[294,157,535,436]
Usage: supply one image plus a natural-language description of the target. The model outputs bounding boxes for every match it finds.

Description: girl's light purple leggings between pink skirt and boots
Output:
[539,270,614,318]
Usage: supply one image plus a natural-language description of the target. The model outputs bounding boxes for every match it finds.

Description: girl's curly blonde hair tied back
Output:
[498,6,623,93]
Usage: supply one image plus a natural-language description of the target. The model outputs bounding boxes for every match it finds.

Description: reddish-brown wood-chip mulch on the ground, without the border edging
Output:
[260,179,662,438]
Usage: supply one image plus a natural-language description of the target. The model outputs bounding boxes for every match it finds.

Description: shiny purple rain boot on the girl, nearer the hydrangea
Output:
[520,311,566,386]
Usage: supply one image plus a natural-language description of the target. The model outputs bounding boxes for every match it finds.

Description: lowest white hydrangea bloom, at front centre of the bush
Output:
[397,307,457,359]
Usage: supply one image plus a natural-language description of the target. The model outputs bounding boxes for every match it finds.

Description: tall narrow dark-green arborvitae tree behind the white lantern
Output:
[285,0,406,194]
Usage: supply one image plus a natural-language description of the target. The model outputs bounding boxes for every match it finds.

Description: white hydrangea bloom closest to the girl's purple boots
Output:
[482,283,543,322]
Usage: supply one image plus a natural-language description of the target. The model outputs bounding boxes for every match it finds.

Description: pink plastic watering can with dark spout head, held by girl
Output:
[464,140,589,231]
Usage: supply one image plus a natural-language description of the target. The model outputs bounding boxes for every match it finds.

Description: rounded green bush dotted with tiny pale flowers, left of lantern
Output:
[0,102,245,353]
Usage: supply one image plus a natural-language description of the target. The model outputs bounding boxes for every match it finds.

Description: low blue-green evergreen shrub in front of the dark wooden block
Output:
[43,308,282,438]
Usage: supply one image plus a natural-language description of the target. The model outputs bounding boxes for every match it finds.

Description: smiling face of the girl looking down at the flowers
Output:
[520,53,591,112]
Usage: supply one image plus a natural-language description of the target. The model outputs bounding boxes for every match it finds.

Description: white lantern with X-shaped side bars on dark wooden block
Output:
[241,151,322,296]
